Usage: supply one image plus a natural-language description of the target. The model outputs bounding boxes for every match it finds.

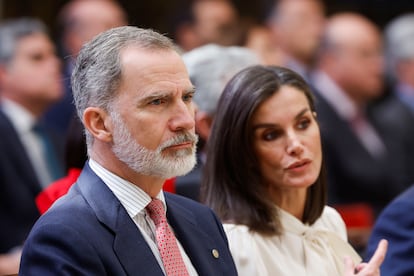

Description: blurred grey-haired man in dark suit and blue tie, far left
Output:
[0,18,64,258]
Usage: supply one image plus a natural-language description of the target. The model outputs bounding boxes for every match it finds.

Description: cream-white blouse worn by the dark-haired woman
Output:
[224,206,361,276]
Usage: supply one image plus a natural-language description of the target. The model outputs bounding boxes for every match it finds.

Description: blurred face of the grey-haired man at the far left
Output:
[2,33,63,109]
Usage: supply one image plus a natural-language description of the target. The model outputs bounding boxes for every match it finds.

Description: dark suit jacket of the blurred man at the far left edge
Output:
[0,110,63,253]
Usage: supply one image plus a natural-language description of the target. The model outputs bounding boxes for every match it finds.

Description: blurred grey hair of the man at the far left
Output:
[0,17,47,65]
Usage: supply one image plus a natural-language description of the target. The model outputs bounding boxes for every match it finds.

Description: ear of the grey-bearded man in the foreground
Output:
[83,107,113,142]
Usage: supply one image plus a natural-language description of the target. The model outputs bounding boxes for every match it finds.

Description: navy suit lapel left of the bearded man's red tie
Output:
[78,165,163,275]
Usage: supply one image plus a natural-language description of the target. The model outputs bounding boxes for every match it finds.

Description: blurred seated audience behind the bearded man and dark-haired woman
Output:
[0,0,414,274]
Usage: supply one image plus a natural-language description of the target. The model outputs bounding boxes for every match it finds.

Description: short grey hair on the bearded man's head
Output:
[71,26,177,148]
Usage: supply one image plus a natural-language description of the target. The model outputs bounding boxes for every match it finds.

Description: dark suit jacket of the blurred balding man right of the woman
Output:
[315,91,408,213]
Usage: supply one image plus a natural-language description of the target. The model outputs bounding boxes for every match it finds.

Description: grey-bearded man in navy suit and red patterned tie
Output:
[19,27,237,275]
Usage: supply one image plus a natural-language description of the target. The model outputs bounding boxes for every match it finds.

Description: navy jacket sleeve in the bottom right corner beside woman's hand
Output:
[367,186,414,276]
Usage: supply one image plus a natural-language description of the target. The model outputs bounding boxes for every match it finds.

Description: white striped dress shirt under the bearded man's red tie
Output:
[89,159,198,275]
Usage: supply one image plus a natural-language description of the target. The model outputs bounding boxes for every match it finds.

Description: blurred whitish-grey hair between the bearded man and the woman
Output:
[183,44,260,116]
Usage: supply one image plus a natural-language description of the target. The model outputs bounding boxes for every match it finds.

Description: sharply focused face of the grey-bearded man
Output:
[111,48,197,178]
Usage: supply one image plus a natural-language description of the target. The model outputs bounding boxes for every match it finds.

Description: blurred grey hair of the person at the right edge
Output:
[384,13,414,81]
